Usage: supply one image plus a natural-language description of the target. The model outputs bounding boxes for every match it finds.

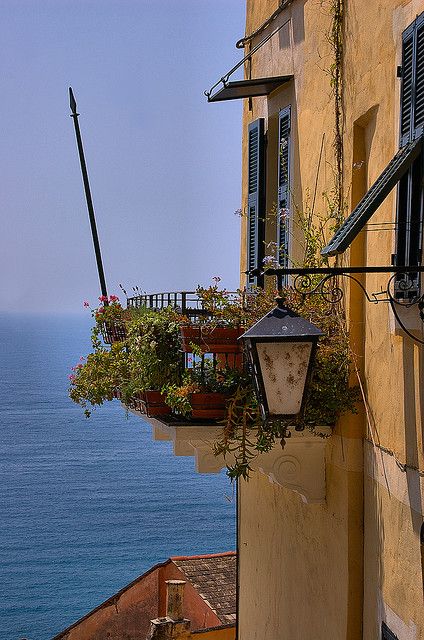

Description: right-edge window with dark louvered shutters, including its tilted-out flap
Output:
[322,13,424,288]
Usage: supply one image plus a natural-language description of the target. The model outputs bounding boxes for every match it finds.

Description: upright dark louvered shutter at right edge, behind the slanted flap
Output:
[393,14,424,299]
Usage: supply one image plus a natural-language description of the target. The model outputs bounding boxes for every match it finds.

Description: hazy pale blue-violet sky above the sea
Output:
[0,0,245,313]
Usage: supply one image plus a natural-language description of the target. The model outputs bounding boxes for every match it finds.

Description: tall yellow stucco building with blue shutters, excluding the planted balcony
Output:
[210,0,424,640]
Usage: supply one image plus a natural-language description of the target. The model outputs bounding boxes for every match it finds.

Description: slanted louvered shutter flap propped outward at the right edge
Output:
[321,138,423,256]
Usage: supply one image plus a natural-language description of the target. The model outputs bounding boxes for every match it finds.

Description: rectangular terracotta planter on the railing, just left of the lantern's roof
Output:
[180,325,244,353]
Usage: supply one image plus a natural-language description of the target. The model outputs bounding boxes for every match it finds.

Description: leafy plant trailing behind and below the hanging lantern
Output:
[215,287,359,478]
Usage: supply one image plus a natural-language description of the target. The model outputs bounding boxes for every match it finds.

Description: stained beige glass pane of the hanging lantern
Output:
[256,342,312,415]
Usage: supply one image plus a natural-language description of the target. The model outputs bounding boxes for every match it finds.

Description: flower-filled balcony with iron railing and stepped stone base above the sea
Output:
[70,283,356,502]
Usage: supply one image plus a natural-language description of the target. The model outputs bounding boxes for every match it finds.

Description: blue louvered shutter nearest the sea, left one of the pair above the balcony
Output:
[246,118,265,289]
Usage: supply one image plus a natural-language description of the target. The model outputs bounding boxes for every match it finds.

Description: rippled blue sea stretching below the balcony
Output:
[0,315,235,640]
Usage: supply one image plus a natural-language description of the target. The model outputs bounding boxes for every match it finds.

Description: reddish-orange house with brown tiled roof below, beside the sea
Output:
[52,552,236,640]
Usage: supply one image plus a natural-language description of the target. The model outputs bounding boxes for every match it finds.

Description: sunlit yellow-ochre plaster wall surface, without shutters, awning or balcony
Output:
[239,0,424,640]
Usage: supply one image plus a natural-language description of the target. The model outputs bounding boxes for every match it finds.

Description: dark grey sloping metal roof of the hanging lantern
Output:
[239,305,323,341]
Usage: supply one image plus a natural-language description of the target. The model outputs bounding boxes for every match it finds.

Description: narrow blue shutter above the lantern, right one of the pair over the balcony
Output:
[277,107,291,267]
